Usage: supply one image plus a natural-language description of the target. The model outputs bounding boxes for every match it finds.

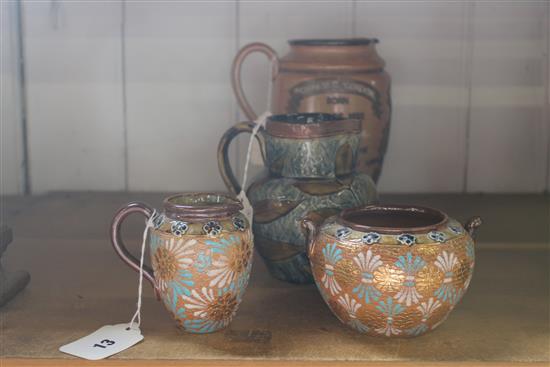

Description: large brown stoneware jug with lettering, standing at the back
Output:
[232,38,391,181]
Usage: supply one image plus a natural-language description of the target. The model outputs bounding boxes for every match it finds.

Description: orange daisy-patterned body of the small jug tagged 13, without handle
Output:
[149,210,253,333]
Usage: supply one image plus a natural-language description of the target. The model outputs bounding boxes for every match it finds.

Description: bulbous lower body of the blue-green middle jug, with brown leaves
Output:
[248,174,377,283]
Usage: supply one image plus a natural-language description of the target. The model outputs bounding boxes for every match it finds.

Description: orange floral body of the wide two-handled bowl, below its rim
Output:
[309,208,479,337]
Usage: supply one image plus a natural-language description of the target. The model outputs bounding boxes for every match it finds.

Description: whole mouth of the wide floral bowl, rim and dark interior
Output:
[338,205,449,234]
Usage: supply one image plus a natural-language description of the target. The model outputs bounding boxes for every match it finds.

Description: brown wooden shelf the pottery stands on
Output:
[0,194,550,366]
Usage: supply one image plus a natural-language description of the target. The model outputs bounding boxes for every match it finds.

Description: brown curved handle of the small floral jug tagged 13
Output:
[111,202,160,300]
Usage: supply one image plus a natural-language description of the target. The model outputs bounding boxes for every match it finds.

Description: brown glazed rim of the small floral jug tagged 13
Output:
[163,191,243,219]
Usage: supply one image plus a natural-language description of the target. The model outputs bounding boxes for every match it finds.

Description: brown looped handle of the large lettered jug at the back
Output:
[231,42,279,120]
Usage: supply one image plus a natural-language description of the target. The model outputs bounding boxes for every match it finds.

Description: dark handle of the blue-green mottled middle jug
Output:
[218,121,265,195]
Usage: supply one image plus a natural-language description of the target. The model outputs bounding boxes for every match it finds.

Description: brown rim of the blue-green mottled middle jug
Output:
[265,113,361,139]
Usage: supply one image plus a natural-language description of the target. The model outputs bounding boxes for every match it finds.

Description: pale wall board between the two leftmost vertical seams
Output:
[23,1,126,193]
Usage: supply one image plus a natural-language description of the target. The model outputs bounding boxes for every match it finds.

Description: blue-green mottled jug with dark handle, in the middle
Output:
[218,113,377,283]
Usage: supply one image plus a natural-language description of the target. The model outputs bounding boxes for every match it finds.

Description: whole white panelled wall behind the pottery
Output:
[1,0,550,194]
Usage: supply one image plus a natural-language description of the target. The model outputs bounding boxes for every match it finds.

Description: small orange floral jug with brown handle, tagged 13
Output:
[111,193,253,333]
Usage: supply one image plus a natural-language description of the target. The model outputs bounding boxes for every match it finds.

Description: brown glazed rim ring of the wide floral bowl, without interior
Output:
[337,204,449,234]
